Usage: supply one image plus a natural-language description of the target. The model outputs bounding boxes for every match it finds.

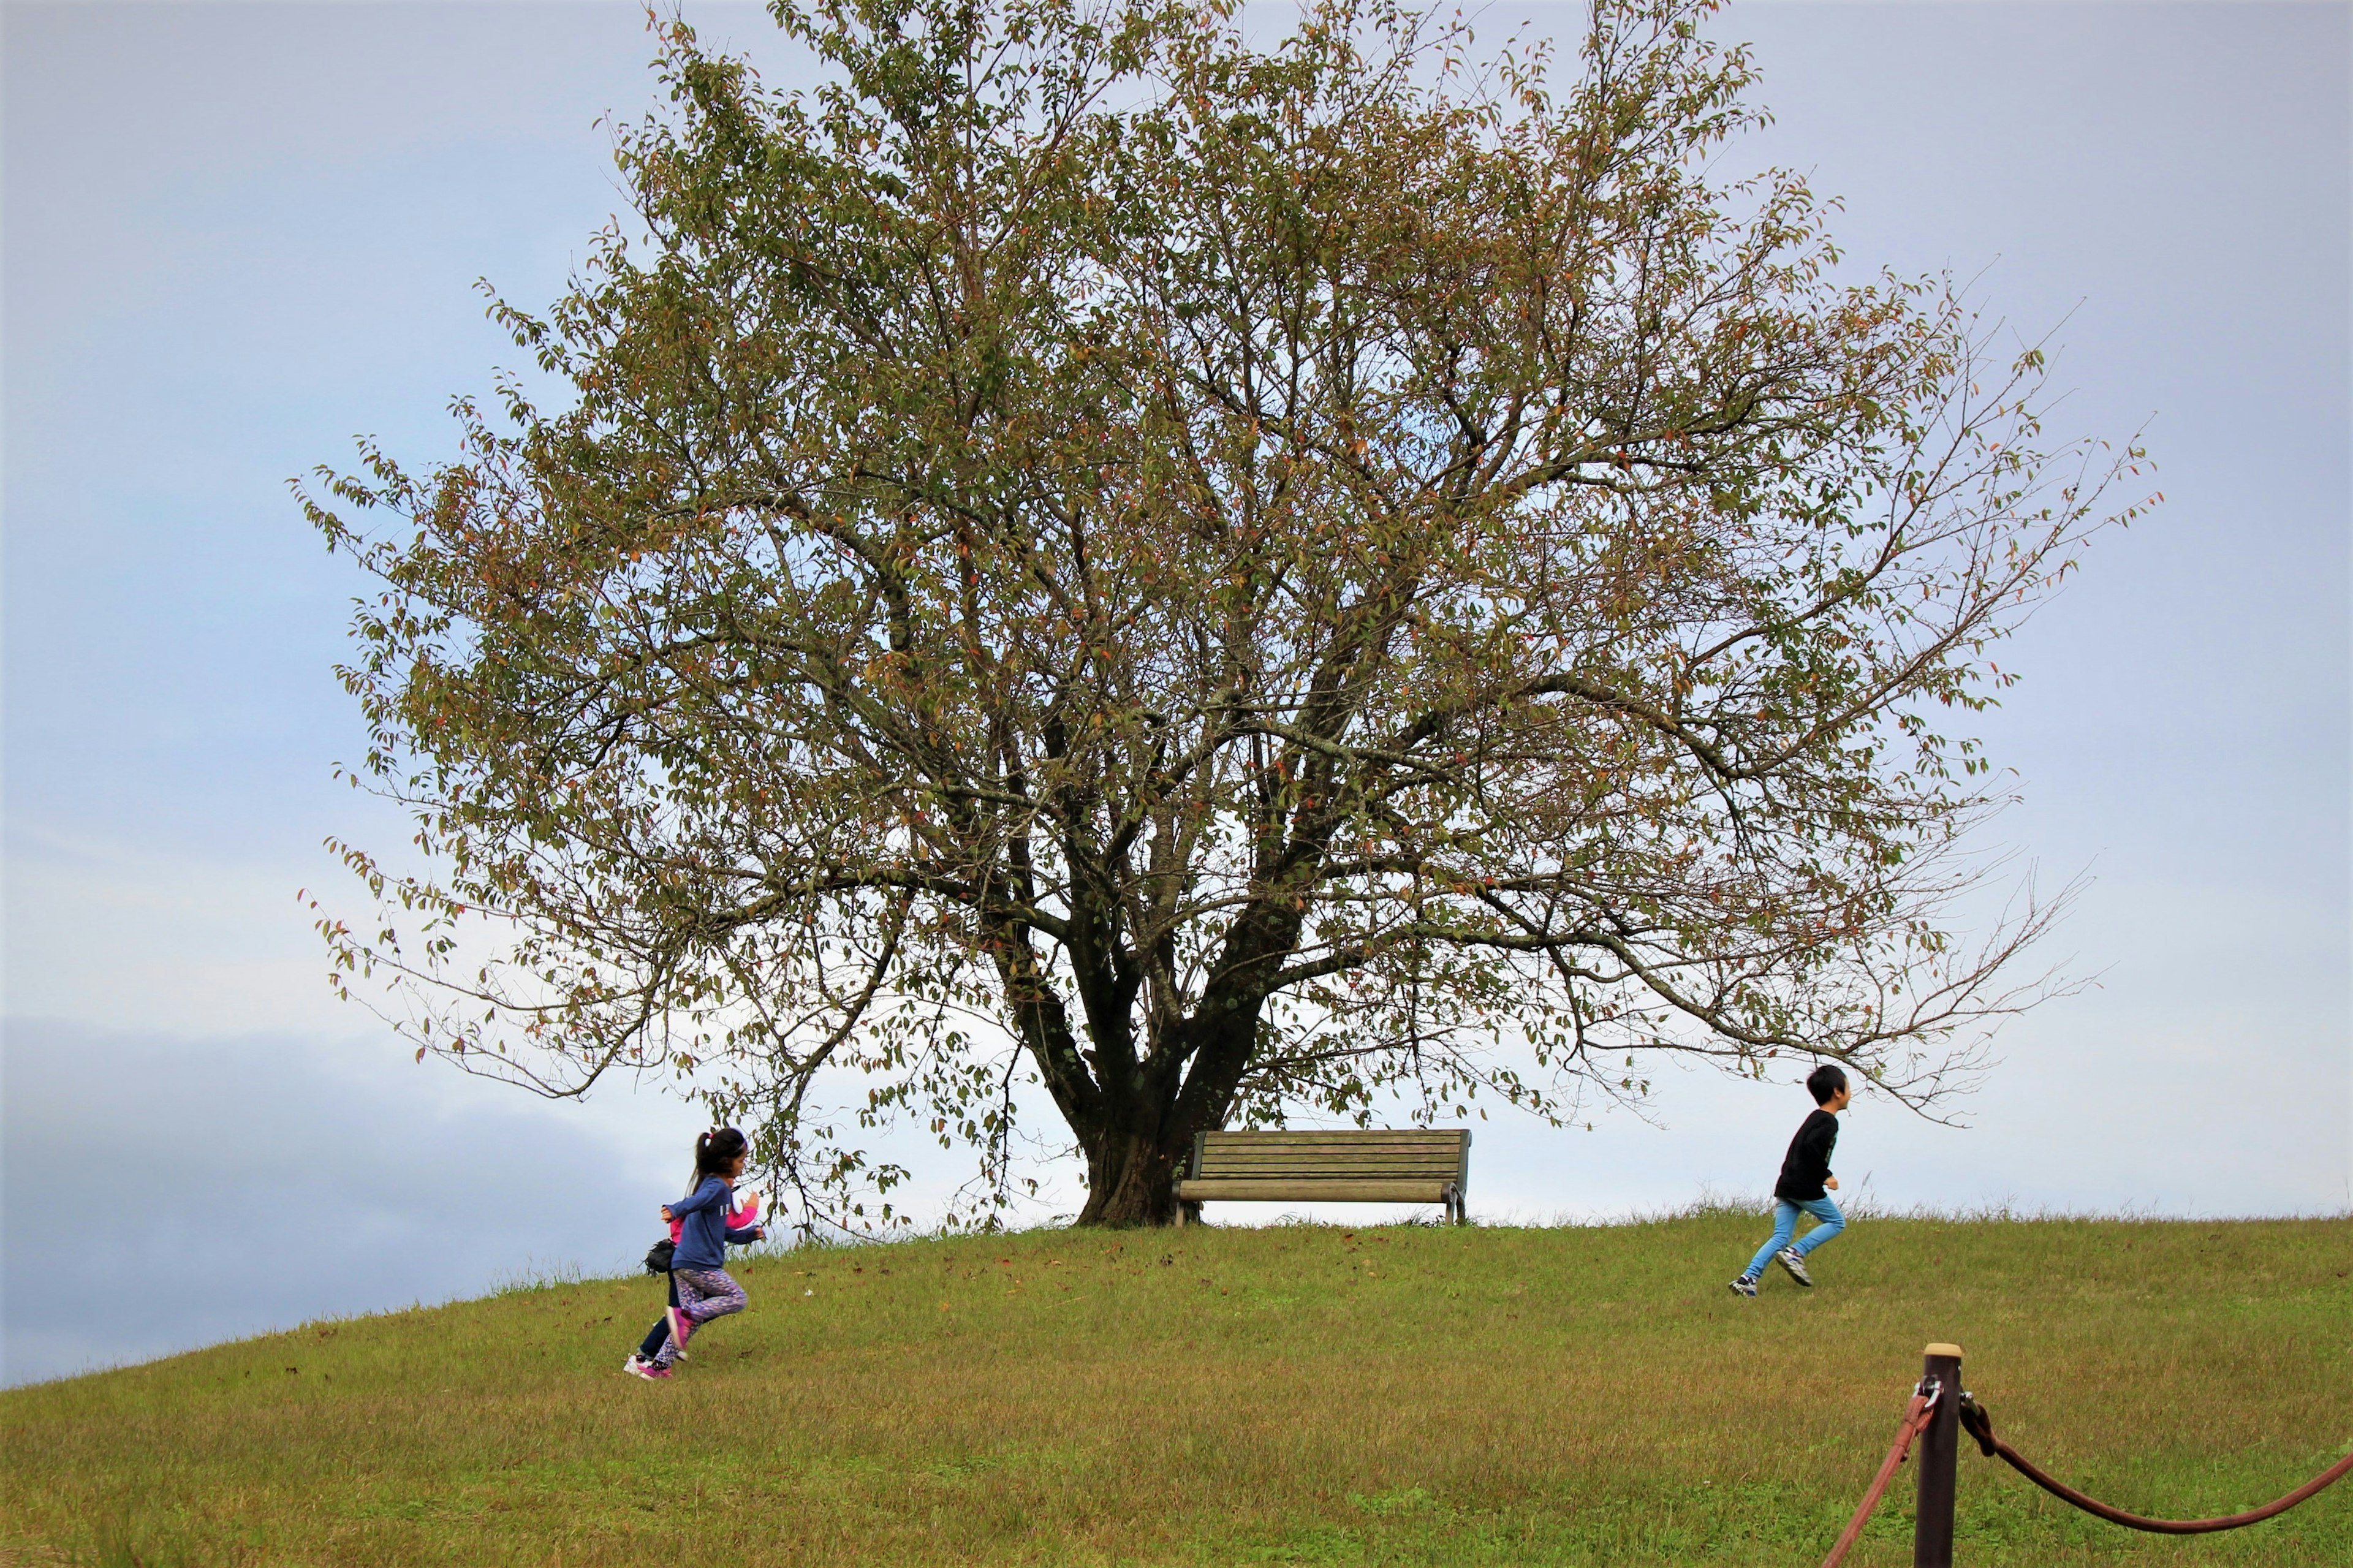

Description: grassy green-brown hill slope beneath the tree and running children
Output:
[0,1215,2353,1568]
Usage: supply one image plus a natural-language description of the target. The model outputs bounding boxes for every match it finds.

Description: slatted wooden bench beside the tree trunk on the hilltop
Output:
[1176,1127,1471,1224]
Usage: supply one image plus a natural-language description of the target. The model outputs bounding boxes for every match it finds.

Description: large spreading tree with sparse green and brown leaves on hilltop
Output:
[306,0,2137,1222]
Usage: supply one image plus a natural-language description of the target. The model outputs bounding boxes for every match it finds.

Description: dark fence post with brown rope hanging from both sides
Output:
[1821,1344,2353,1568]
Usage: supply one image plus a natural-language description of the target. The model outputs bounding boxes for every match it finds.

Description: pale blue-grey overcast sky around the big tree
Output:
[0,2,2353,1380]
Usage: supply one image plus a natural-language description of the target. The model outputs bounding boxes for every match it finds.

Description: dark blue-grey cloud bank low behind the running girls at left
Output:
[0,1020,694,1382]
